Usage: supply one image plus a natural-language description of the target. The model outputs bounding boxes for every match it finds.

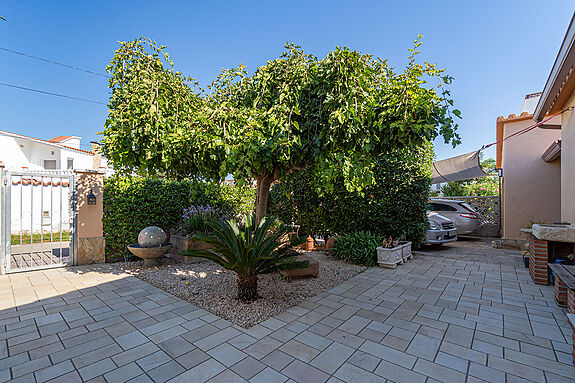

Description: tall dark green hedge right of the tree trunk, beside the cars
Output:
[269,145,433,246]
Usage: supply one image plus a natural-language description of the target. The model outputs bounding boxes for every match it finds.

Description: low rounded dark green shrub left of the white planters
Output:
[332,231,381,266]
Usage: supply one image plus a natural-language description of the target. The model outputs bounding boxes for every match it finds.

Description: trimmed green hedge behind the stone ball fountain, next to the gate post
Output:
[102,176,255,261]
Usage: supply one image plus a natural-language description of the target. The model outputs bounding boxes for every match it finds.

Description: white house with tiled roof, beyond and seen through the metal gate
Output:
[0,130,112,234]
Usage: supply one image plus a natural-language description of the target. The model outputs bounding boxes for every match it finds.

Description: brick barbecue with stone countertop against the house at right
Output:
[529,224,575,285]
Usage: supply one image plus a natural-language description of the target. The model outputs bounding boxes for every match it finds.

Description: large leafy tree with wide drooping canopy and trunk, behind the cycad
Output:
[103,39,459,222]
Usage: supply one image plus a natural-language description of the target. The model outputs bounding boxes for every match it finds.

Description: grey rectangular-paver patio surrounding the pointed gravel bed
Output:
[0,241,575,383]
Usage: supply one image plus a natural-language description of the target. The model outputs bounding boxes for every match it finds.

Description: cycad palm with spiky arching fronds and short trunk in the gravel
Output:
[182,216,308,302]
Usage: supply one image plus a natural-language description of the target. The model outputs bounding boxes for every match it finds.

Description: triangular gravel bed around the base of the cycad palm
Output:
[114,252,366,328]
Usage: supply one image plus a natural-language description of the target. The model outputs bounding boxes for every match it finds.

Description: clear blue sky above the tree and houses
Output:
[0,0,574,159]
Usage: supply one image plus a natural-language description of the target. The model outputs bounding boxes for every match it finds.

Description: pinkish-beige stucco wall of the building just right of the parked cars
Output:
[502,119,562,239]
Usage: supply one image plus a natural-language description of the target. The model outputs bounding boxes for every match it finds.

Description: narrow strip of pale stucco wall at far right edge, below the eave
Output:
[561,93,575,224]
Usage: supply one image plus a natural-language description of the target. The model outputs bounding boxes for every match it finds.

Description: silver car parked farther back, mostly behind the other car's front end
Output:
[429,199,485,235]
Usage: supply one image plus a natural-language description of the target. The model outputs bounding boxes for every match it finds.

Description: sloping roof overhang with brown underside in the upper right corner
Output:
[533,14,575,121]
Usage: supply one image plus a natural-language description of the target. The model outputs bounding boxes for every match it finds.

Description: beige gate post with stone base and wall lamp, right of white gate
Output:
[75,170,106,265]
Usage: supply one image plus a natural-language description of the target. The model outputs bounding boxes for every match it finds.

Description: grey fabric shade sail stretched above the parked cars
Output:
[431,151,489,184]
